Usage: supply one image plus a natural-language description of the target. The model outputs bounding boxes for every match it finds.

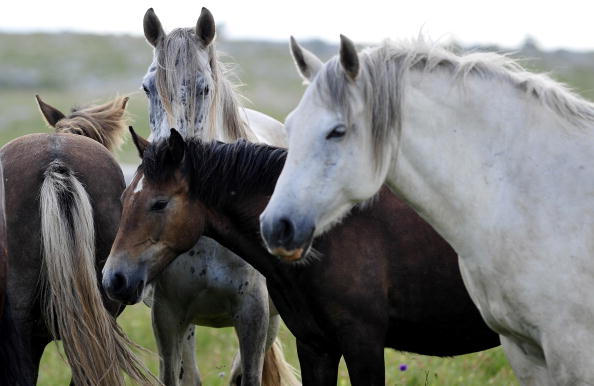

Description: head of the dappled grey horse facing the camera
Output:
[142,8,216,139]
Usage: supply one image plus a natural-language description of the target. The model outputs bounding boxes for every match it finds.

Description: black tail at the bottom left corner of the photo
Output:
[0,294,33,386]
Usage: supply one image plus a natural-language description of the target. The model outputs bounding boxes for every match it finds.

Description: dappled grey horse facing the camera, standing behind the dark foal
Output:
[139,8,297,385]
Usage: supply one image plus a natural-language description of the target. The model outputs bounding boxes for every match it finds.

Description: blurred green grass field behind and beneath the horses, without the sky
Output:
[0,30,594,386]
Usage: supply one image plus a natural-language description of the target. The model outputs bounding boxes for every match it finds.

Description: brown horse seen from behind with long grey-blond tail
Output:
[0,95,154,385]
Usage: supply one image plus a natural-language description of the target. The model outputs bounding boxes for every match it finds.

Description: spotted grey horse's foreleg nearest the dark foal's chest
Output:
[232,290,269,386]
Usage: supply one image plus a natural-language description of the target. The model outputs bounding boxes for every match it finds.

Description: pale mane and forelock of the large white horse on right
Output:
[314,37,594,167]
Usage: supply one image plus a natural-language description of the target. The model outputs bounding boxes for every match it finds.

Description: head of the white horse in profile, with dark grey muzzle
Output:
[260,36,397,256]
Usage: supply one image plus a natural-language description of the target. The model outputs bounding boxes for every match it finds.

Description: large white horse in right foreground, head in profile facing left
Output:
[260,37,594,385]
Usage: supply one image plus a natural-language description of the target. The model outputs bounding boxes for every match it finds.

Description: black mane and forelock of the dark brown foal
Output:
[142,139,287,206]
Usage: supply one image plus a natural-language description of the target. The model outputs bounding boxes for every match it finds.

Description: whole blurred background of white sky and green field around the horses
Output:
[0,0,594,385]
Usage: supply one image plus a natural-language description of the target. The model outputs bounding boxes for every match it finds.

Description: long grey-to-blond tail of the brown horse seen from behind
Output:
[40,160,158,386]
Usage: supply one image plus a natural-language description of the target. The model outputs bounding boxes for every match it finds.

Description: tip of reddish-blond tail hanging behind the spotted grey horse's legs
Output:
[262,338,301,386]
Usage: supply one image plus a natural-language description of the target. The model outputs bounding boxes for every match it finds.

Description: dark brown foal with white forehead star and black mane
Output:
[103,130,499,385]
